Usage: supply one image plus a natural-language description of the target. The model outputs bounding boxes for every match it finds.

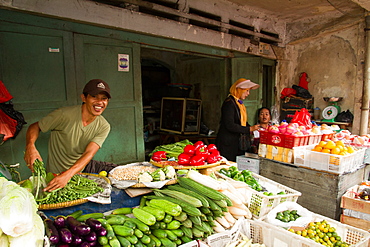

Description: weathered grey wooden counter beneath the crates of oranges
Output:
[260,158,365,221]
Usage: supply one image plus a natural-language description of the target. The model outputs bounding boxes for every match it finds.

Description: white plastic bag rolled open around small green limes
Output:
[266,201,313,228]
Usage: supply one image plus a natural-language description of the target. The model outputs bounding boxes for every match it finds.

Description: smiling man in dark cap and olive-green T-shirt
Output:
[24,79,117,191]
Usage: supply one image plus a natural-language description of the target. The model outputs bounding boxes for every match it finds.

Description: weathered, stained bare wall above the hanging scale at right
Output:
[279,22,365,134]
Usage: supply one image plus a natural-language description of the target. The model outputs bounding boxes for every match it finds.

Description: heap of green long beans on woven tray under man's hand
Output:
[36,175,103,204]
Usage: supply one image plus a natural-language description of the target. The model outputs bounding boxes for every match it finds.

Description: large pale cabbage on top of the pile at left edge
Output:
[0,181,37,237]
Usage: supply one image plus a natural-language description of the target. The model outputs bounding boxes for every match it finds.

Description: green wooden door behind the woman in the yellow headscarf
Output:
[231,57,263,125]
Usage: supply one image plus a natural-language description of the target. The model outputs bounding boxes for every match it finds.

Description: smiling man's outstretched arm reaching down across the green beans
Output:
[44,142,100,191]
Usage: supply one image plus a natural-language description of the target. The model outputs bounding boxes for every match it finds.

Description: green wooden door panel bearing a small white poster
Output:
[74,35,144,164]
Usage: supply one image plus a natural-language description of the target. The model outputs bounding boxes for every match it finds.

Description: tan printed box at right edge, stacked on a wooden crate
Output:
[340,185,370,214]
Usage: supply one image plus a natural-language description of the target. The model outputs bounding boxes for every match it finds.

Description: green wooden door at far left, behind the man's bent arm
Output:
[0,22,76,178]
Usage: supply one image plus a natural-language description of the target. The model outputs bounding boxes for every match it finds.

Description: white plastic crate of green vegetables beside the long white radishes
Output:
[217,168,302,219]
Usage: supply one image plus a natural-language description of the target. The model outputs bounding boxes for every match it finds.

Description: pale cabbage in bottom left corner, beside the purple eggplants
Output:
[7,213,45,247]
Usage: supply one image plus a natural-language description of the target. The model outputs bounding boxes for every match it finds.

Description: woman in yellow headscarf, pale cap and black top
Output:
[216,78,259,162]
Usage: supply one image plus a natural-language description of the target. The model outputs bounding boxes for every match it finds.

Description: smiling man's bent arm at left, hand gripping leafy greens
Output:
[24,122,42,171]
